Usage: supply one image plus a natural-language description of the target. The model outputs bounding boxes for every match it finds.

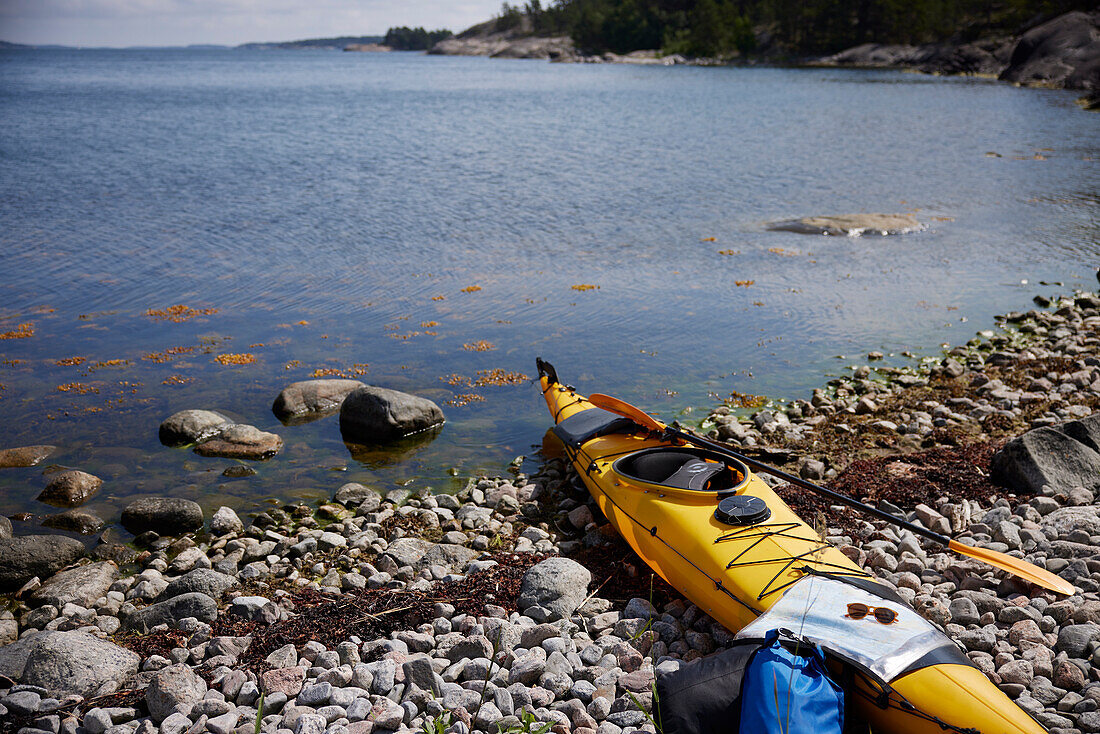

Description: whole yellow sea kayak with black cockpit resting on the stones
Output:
[538,360,1046,734]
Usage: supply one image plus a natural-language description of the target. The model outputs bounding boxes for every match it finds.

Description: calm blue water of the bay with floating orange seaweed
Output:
[0,51,1100,527]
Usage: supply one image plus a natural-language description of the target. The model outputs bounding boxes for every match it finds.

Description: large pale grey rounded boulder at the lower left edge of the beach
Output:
[0,632,141,698]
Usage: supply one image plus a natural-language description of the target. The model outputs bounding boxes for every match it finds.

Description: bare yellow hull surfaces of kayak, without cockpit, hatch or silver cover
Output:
[540,369,1046,734]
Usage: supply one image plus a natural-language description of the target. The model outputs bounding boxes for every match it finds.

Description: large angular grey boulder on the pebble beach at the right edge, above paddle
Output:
[990,427,1100,494]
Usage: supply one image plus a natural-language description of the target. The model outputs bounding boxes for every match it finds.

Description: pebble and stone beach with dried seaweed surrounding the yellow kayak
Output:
[0,286,1100,734]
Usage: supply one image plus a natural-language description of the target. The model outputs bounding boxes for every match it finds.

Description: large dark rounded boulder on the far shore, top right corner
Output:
[1001,11,1100,89]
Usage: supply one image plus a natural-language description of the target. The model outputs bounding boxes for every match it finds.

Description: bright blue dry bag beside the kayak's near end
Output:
[740,629,844,734]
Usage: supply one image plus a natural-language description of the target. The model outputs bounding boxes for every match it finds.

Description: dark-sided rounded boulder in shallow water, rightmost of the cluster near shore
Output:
[340,386,443,443]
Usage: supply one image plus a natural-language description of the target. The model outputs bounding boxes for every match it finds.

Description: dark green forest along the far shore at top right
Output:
[510,0,1095,57]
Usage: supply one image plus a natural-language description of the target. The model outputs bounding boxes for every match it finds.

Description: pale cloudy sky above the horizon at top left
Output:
[0,0,501,46]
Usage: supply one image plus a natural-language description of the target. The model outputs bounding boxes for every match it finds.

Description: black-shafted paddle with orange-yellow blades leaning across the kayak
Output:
[589,393,1075,595]
